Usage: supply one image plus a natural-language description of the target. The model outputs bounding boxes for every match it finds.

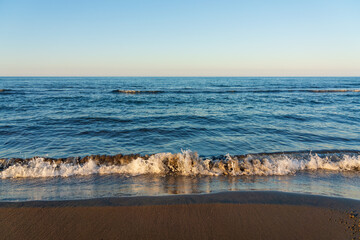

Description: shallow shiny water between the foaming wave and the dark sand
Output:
[0,171,360,201]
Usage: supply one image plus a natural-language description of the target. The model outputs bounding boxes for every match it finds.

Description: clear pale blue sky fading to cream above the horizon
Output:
[0,0,360,76]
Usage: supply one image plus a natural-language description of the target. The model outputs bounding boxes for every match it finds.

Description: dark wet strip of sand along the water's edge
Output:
[0,190,360,210]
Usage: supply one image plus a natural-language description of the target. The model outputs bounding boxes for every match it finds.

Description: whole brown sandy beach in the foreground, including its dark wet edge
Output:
[0,192,360,239]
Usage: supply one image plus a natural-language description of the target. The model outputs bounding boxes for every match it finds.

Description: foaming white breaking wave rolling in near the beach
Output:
[0,150,360,179]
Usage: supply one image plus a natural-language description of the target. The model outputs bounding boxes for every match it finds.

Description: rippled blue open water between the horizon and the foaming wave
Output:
[0,77,360,157]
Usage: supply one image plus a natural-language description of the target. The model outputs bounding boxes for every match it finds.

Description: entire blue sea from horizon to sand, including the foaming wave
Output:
[0,77,360,201]
